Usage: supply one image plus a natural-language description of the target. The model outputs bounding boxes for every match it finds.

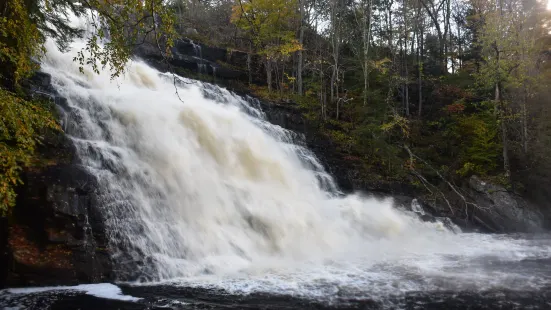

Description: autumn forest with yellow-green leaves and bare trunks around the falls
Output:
[0,0,551,210]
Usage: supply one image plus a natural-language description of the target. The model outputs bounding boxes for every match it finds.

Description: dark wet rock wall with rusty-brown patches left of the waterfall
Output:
[0,74,113,287]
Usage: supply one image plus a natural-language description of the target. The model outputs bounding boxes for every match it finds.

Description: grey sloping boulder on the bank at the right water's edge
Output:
[469,176,544,232]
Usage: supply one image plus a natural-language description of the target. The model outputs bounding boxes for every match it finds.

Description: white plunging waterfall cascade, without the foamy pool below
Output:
[43,35,444,280]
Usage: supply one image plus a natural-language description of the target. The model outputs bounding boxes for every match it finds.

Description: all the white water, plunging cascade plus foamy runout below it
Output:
[43,30,551,304]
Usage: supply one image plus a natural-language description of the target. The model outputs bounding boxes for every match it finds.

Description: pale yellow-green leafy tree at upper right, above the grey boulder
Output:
[477,0,546,177]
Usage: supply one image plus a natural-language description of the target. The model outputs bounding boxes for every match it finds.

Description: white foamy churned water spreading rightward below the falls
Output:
[146,234,551,301]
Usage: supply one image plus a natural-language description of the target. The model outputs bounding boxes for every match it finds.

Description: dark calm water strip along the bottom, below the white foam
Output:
[0,286,551,310]
